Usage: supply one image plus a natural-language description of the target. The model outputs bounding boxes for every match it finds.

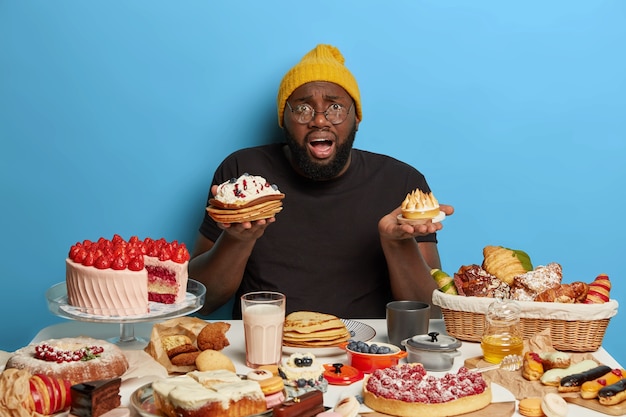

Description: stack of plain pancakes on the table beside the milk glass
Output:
[283,311,351,348]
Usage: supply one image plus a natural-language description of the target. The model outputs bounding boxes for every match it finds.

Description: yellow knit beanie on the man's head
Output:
[276,44,362,127]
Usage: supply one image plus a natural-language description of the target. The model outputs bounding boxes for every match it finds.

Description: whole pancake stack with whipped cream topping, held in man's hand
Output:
[207,173,285,223]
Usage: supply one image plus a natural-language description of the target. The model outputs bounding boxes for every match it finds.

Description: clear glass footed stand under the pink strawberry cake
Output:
[46,279,206,349]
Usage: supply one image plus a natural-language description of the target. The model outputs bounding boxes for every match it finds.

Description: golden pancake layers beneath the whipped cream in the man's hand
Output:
[207,194,285,223]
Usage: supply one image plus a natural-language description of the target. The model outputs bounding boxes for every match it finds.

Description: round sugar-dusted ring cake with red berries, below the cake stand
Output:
[6,337,128,384]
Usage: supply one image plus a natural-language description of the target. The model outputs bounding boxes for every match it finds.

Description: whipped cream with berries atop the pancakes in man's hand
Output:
[214,173,281,205]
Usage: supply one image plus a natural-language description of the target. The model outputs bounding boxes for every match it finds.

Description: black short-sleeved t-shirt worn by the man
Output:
[200,144,436,318]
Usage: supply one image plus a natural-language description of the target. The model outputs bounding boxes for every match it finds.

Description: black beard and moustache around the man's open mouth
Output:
[285,126,356,181]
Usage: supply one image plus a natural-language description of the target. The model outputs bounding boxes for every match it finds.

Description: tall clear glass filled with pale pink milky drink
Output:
[241,291,286,368]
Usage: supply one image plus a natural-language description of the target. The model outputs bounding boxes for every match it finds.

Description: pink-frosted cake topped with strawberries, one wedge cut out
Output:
[65,235,189,316]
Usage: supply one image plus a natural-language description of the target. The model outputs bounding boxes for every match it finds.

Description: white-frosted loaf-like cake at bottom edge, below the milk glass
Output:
[152,370,267,417]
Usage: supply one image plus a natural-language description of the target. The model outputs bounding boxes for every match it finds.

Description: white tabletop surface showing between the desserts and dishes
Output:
[33,319,621,417]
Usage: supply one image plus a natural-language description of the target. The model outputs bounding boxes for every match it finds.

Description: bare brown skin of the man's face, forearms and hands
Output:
[189,82,454,317]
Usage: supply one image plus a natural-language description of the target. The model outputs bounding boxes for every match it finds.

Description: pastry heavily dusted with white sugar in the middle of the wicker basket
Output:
[511,262,563,301]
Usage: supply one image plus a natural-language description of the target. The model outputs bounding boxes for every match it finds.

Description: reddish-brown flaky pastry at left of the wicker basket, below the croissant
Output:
[454,264,511,298]
